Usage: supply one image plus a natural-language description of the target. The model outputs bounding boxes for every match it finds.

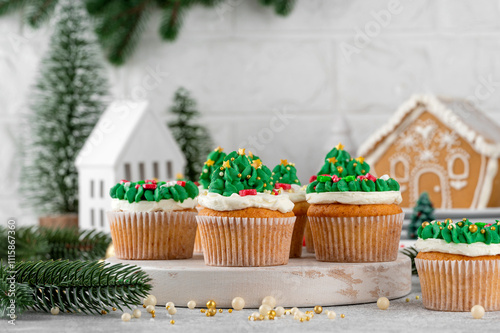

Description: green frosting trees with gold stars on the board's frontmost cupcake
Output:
[208,148,273,196]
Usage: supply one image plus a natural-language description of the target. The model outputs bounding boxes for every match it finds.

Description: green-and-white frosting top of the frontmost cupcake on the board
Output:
[198,148,294,213]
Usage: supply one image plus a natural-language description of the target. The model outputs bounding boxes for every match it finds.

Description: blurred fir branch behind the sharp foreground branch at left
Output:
[0,227,111,261]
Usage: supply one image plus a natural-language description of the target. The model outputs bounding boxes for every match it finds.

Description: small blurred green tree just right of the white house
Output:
[168,88,213,182]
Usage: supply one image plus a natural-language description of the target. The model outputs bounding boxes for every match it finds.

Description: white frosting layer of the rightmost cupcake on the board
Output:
[306,191,403,205]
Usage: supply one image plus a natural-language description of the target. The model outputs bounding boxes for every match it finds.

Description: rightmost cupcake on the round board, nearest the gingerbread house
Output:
[306,144,404,262]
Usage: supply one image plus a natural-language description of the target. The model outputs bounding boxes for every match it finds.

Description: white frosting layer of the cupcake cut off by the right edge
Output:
[415,238,500,257]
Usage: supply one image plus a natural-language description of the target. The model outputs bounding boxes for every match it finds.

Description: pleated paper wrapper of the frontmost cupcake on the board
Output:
[196,216,295,267]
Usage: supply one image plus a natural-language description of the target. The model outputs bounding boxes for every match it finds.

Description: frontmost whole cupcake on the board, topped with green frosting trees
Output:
[197,149,295,267]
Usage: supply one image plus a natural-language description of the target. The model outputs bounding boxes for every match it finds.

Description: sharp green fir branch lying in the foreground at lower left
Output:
[0,261,151,316]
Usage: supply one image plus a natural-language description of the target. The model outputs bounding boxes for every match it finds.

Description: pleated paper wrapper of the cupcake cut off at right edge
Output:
[415,258,500,311]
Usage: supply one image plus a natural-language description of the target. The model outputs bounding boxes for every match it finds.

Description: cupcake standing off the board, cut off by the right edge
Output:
[415,219,500,311]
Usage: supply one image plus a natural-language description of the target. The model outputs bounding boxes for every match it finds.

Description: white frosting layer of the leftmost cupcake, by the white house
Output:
[111,198,198,212]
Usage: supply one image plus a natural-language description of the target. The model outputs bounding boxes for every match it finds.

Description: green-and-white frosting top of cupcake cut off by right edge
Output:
[415,218,500,257]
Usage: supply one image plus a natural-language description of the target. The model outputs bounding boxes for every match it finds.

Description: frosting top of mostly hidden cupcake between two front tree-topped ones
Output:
[271,160,306,203]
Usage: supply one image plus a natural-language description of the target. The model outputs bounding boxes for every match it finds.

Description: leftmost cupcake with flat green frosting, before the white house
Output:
[107,180,198,260]
